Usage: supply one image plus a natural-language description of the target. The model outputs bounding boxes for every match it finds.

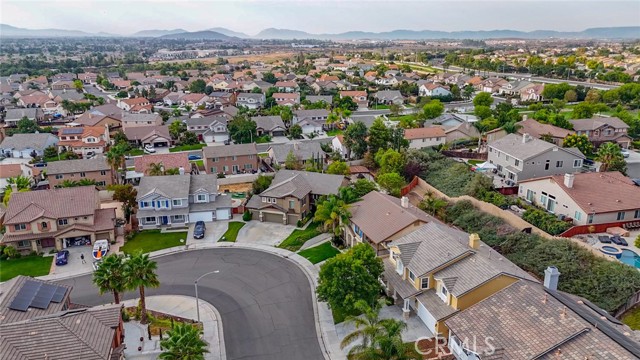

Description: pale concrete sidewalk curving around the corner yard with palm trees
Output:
[123,295,227,360]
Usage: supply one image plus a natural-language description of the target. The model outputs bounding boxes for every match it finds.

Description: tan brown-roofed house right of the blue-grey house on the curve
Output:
[246,170,348,225]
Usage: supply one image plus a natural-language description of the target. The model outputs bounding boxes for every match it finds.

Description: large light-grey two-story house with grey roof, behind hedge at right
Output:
[488,134,585,185]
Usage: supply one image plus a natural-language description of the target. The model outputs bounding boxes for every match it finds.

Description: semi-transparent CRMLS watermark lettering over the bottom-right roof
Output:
[415,335,496,356]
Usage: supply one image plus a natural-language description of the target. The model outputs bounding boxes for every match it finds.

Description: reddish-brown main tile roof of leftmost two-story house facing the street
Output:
[5,186,98,224]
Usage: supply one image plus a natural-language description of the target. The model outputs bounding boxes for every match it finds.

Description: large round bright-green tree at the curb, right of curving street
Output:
[317,244,384,314]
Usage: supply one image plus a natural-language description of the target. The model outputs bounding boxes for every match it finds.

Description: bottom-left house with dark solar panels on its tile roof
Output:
[0,275,125,360]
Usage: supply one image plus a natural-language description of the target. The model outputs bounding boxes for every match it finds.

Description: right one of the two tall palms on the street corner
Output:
[125,252,160,324]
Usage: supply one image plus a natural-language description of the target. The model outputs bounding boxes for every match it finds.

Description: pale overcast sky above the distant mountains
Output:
[0,0,640,35]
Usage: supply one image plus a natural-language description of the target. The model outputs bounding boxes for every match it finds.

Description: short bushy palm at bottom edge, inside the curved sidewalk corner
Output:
[159,323,209,360]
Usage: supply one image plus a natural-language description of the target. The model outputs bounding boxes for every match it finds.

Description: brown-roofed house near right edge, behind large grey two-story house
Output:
[569,117,633,149]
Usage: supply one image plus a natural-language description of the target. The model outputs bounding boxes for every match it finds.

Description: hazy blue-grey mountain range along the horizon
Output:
[0,24,640,41]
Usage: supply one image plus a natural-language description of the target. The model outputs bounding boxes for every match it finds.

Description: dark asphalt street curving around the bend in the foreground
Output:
[57,249,323,360]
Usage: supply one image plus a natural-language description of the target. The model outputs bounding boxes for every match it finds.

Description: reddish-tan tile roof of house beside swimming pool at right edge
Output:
[521,171,640,214]
